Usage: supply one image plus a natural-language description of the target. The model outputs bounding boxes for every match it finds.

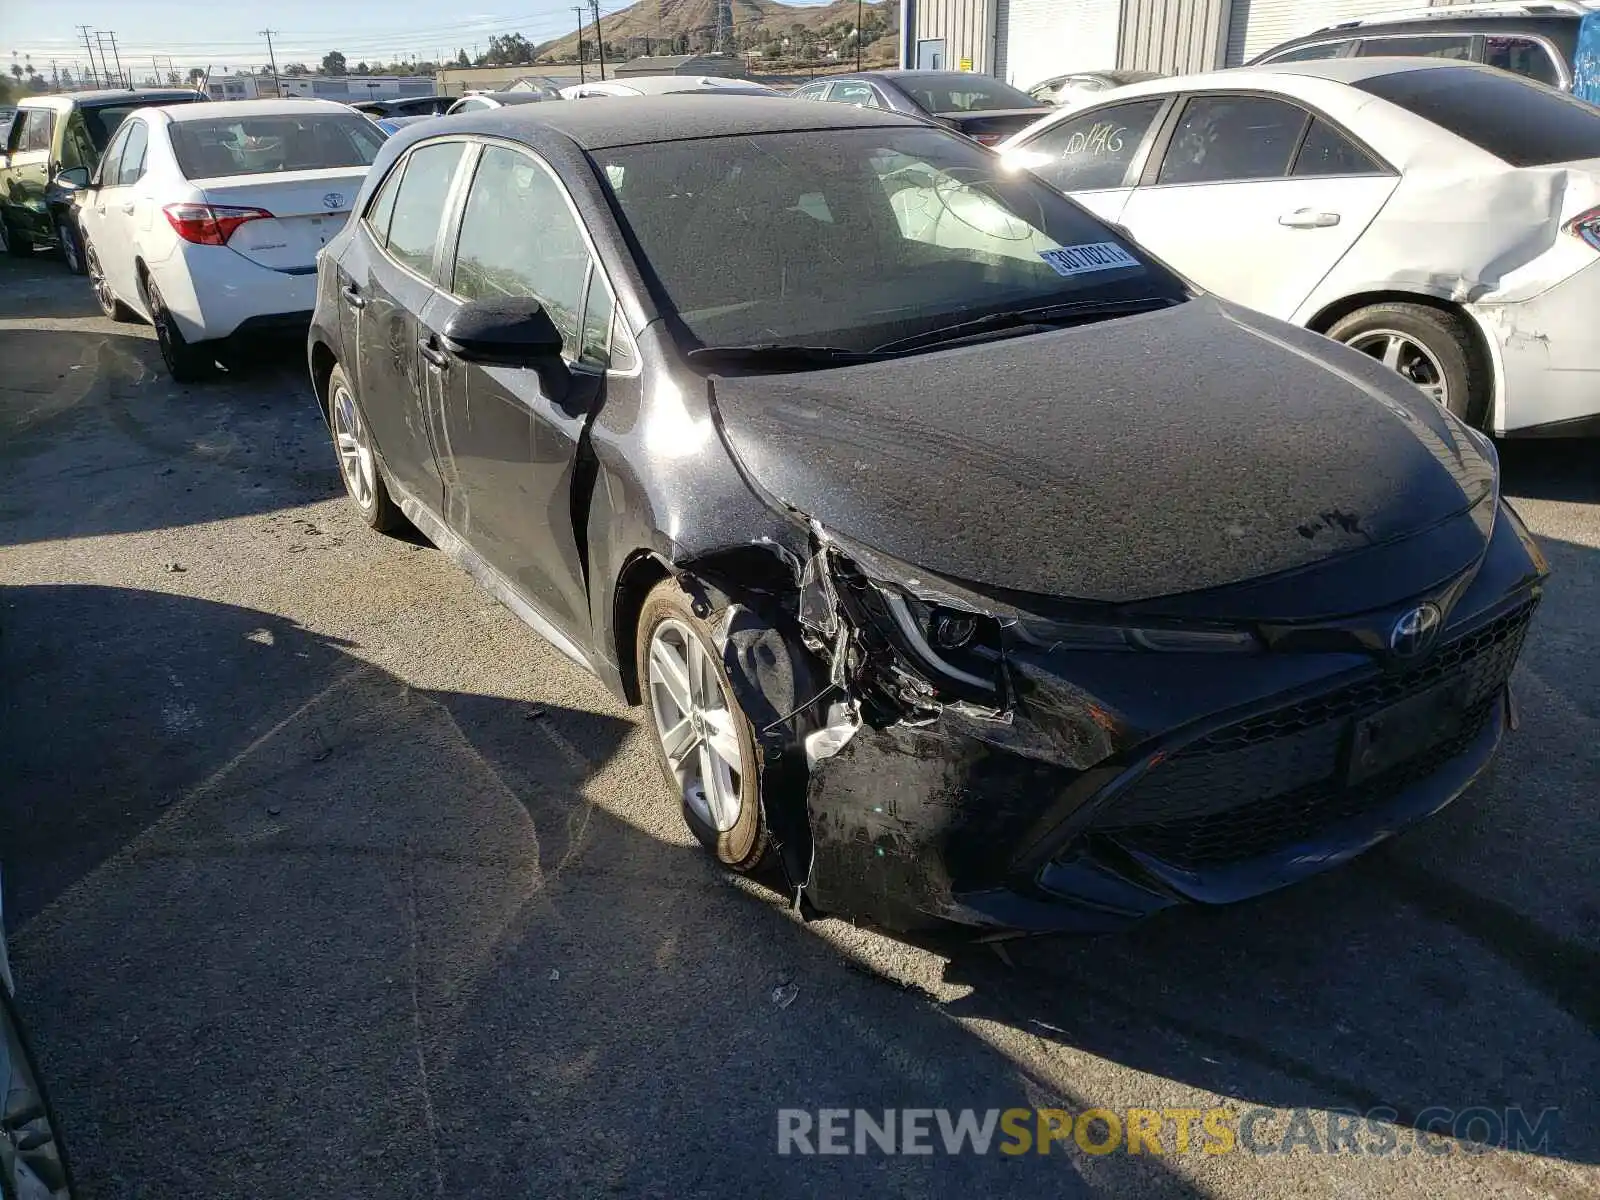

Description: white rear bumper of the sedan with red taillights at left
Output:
[147,243,317,342]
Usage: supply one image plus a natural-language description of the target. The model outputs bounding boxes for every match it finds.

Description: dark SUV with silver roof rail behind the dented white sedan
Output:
[1250,0,1600,104]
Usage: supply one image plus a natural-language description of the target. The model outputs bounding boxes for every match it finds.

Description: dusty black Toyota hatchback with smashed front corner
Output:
[309,96,1546,933]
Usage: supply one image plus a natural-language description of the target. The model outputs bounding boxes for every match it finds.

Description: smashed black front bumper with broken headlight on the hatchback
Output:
[698,510,1544,938]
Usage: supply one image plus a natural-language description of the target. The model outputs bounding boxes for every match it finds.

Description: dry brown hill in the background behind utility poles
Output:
[534,0,899,61]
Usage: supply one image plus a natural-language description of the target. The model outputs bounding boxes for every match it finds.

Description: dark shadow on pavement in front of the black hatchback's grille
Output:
[946,539,1600,1163]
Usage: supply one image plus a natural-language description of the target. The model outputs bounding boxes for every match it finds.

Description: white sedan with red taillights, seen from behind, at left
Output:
[68,99,386,381]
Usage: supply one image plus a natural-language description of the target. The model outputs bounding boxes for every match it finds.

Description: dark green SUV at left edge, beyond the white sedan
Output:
[0,88,205,275]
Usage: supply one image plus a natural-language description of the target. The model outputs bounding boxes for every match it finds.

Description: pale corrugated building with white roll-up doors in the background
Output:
[901,0,1497,88]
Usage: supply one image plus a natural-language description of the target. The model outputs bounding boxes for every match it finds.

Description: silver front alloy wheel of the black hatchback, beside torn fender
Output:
[648,618,742,834]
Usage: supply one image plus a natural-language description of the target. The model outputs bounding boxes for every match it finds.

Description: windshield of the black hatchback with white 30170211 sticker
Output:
[595,126,1186,360]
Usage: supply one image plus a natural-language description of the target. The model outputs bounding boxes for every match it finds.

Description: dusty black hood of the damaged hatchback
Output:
[712,298,1496,603]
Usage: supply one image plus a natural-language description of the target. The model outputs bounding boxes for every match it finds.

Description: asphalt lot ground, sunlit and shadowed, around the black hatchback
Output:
[0,259,1600,1200]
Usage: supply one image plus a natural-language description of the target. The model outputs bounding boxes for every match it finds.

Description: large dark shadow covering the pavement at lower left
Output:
[0,586,1198,1200]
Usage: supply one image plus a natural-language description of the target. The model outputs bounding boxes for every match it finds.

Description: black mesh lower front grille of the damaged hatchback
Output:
[1091,602,1536,867]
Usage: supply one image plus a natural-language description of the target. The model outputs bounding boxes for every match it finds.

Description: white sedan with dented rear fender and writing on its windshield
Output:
[1004,58,1600,435]
